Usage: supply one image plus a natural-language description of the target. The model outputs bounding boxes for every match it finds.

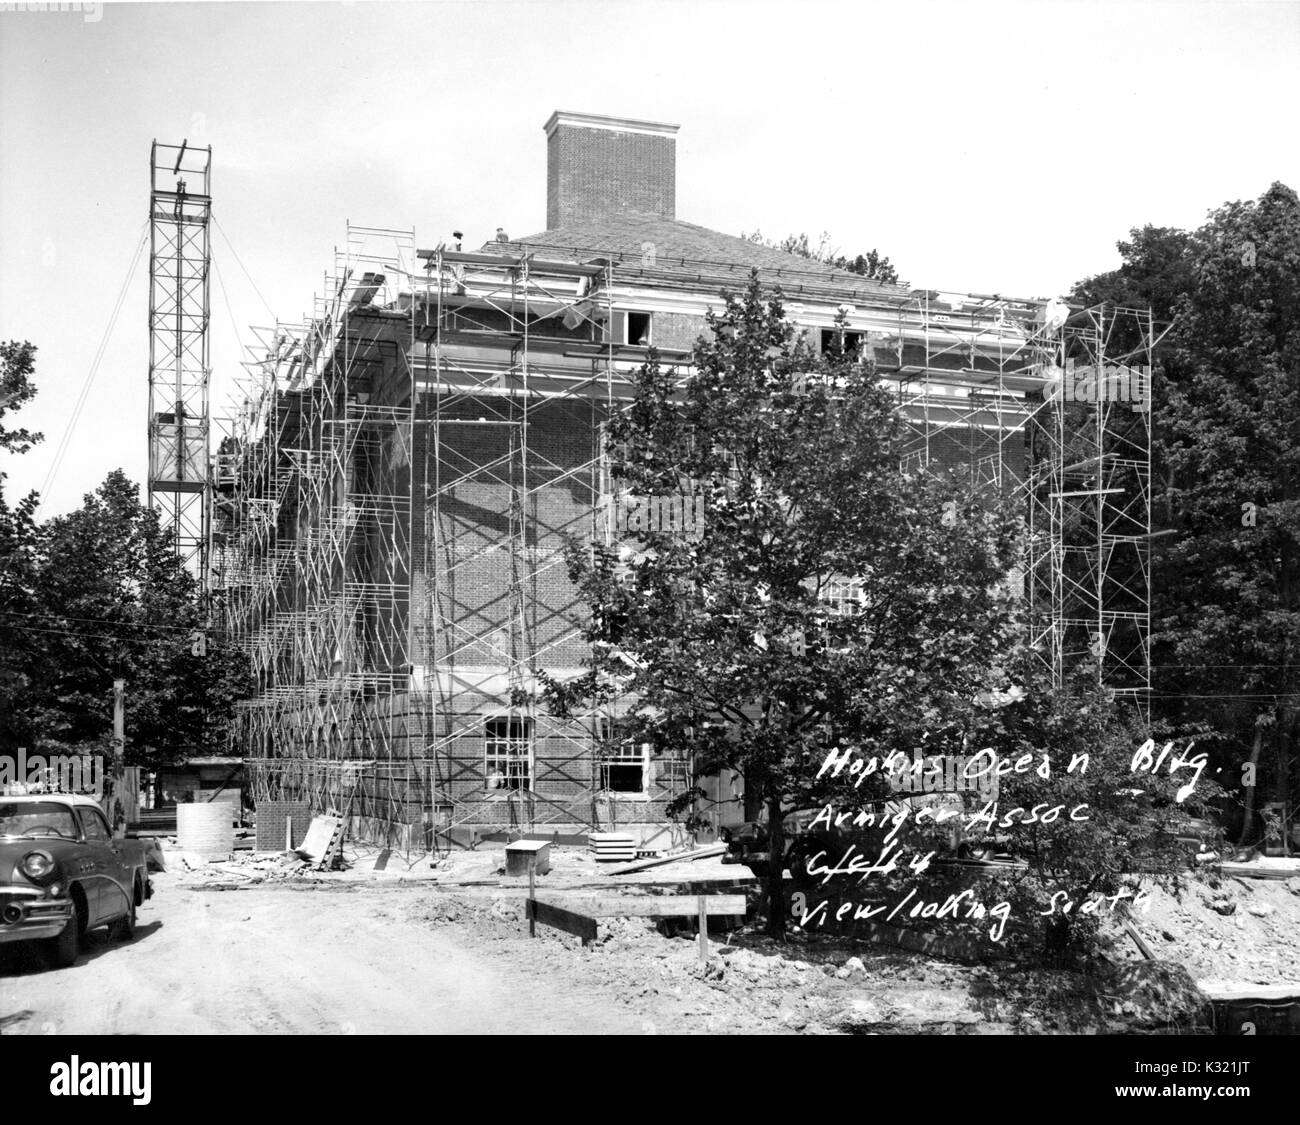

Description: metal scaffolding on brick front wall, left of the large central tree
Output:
[413,248,688,832]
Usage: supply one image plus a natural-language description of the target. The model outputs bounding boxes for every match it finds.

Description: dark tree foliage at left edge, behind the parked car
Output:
[0,343,247,769]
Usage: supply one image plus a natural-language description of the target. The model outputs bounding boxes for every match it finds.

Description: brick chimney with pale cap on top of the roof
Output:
[545,109,677,230]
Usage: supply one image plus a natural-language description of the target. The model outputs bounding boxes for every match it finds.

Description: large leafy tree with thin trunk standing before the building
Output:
[541,273,1018,934]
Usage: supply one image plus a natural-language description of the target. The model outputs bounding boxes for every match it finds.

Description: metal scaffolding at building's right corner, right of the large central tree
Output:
[875,293,1158,715]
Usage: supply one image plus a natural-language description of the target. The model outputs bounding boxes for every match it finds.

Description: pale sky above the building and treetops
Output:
[0,0,1300,515]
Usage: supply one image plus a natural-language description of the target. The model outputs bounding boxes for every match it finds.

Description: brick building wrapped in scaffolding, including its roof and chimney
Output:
[211,112,1152,848]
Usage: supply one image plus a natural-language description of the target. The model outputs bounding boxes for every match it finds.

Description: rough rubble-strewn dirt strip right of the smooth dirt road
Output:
[404,888,1248,1034]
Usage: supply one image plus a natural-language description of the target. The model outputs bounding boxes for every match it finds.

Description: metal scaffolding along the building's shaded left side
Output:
[217,226,420,842]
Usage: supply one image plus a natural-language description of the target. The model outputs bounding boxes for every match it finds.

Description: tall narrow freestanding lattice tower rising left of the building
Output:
[147,140,212,590]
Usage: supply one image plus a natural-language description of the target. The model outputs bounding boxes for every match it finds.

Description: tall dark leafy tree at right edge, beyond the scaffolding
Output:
[1075,183,1300,840]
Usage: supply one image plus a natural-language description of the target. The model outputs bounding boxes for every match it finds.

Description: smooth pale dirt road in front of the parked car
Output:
[0,875,655,1035]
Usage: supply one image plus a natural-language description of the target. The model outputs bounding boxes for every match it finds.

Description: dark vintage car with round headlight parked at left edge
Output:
[0,793,153,968]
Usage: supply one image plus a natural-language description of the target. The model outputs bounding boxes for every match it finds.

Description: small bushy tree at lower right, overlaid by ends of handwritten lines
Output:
[946,663,1218,962]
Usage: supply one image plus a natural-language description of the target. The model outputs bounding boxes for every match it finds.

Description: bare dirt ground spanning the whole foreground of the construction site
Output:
[0,849,1300,1034]
